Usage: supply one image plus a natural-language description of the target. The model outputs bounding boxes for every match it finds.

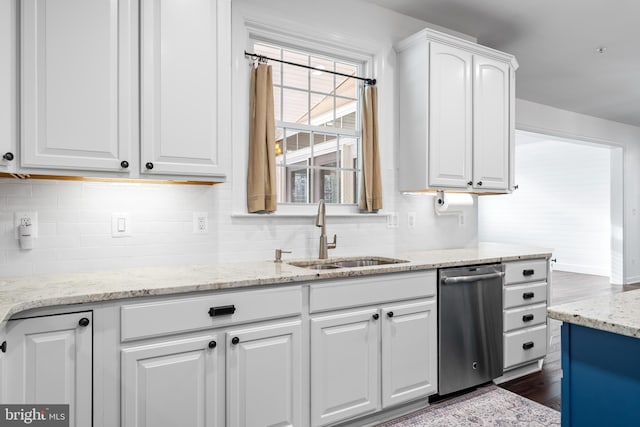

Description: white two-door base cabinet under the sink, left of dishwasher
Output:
[310,272,438,427]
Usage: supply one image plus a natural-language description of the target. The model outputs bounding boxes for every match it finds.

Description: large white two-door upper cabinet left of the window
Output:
[12,0,231,181]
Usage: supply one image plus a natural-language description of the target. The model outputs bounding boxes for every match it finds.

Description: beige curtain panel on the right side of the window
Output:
[360,85,382,212]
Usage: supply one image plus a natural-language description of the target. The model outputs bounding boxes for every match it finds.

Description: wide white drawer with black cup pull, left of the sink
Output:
[120,286,302,341]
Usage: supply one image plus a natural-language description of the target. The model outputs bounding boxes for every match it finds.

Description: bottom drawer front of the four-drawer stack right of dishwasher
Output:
[504,325,547,369]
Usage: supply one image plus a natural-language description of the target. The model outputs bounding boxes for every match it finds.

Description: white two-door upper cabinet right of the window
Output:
[396,30,517,193]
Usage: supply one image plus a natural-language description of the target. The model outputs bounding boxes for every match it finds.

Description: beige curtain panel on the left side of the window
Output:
[247,64,277,212]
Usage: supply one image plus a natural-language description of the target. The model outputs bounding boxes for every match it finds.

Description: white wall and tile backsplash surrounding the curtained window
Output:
[0,0,477,277]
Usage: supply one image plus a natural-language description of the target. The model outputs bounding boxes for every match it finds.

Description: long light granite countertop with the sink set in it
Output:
[0,243,551,327]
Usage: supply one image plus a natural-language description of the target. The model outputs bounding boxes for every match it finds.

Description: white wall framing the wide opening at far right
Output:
[516,100,640,283]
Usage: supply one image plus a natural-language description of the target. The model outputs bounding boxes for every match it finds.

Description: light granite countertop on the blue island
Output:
[547,289,640,338]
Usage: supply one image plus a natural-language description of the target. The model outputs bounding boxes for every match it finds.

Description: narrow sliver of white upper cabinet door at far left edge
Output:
[0,1,18,172]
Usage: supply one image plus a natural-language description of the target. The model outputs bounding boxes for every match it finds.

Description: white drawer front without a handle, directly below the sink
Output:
[309,270,437,313]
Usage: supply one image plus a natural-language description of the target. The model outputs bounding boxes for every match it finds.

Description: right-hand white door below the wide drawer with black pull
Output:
[227,320,302,427]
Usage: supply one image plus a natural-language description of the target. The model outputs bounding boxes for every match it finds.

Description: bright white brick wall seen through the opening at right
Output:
[478,133,611,276]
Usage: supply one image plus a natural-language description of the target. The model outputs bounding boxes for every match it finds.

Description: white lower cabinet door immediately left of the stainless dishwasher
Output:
[381,300,438,408]
